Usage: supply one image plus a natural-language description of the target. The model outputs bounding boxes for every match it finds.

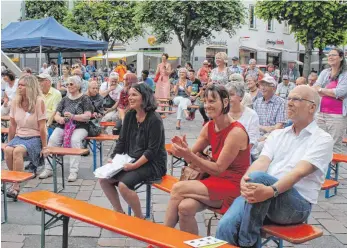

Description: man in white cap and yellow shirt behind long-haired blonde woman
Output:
[37,73,62,126]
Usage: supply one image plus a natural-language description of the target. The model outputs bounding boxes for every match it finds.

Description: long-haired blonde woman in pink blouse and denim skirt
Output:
[5,75,49,199]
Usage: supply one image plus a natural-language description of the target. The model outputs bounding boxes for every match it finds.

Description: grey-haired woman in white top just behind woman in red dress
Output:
[226,81,260,151]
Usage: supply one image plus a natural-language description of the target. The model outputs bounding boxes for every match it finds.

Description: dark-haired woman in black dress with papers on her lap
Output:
[99,84,167,218]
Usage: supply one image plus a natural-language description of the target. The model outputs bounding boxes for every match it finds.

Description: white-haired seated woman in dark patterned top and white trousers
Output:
[39,76,93,182]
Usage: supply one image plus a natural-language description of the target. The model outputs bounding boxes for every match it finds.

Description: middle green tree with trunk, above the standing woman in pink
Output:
[137,0,245,63]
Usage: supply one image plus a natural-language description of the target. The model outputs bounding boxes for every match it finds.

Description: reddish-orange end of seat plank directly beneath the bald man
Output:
[262,224,323,244]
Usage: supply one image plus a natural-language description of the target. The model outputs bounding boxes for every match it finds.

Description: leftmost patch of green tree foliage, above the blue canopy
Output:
[25,0,68,23]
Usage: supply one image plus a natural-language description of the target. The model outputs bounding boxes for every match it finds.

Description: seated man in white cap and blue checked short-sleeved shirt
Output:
[252,74,286,158]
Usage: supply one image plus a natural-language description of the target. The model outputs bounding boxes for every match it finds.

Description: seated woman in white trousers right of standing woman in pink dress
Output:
[173,68,193,130]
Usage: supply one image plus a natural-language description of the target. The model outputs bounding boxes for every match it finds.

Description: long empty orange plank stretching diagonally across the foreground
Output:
[18,191,235,248]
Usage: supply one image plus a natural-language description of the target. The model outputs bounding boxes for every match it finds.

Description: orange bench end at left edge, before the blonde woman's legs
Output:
[1,170,35,224]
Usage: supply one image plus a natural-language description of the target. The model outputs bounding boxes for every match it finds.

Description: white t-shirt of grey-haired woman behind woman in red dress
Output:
[237,107,260,146]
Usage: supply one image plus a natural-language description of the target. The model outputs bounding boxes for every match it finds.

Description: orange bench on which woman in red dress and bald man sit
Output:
[153,175,323,248]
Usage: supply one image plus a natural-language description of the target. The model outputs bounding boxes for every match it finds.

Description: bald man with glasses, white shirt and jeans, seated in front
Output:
[216,85,333,247]
